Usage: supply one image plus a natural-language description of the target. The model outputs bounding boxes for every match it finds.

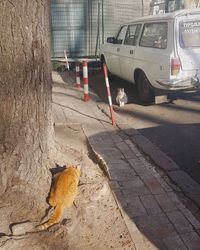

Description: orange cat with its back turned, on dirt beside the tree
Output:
[37,166,80,230]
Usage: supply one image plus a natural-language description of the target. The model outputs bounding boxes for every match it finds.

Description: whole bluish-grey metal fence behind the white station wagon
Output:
[51,0,150,57]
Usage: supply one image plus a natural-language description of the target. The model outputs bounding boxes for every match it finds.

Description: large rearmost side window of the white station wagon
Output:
[140,23,167,49]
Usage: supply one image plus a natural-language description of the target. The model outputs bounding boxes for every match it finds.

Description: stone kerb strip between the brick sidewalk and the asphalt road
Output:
[97,102,200,208]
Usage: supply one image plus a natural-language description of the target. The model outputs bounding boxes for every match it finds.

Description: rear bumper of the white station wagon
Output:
[156,75,200,90]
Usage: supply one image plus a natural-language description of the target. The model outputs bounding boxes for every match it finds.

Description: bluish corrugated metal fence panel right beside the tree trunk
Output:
[51,0,87,57]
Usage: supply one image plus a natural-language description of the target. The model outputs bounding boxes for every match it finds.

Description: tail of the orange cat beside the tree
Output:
[36,205,63,231]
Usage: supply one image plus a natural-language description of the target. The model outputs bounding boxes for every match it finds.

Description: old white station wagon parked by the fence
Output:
[100,8,200,102]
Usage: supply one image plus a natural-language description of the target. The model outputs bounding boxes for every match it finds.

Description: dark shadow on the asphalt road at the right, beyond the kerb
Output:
[138,123,200,184]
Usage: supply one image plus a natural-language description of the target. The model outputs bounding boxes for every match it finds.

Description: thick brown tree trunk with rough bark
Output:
[0,0,54,229]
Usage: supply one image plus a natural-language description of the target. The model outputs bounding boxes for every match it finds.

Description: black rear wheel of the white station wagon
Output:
[137,72,155,103]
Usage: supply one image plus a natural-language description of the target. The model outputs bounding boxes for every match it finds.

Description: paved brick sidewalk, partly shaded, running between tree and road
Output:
[53,72,200,250]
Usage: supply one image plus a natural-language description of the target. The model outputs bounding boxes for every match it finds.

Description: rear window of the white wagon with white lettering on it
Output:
[179,20,200,48]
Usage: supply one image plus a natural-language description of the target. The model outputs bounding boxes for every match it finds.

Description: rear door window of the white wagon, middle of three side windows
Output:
[124,24,142,46]
